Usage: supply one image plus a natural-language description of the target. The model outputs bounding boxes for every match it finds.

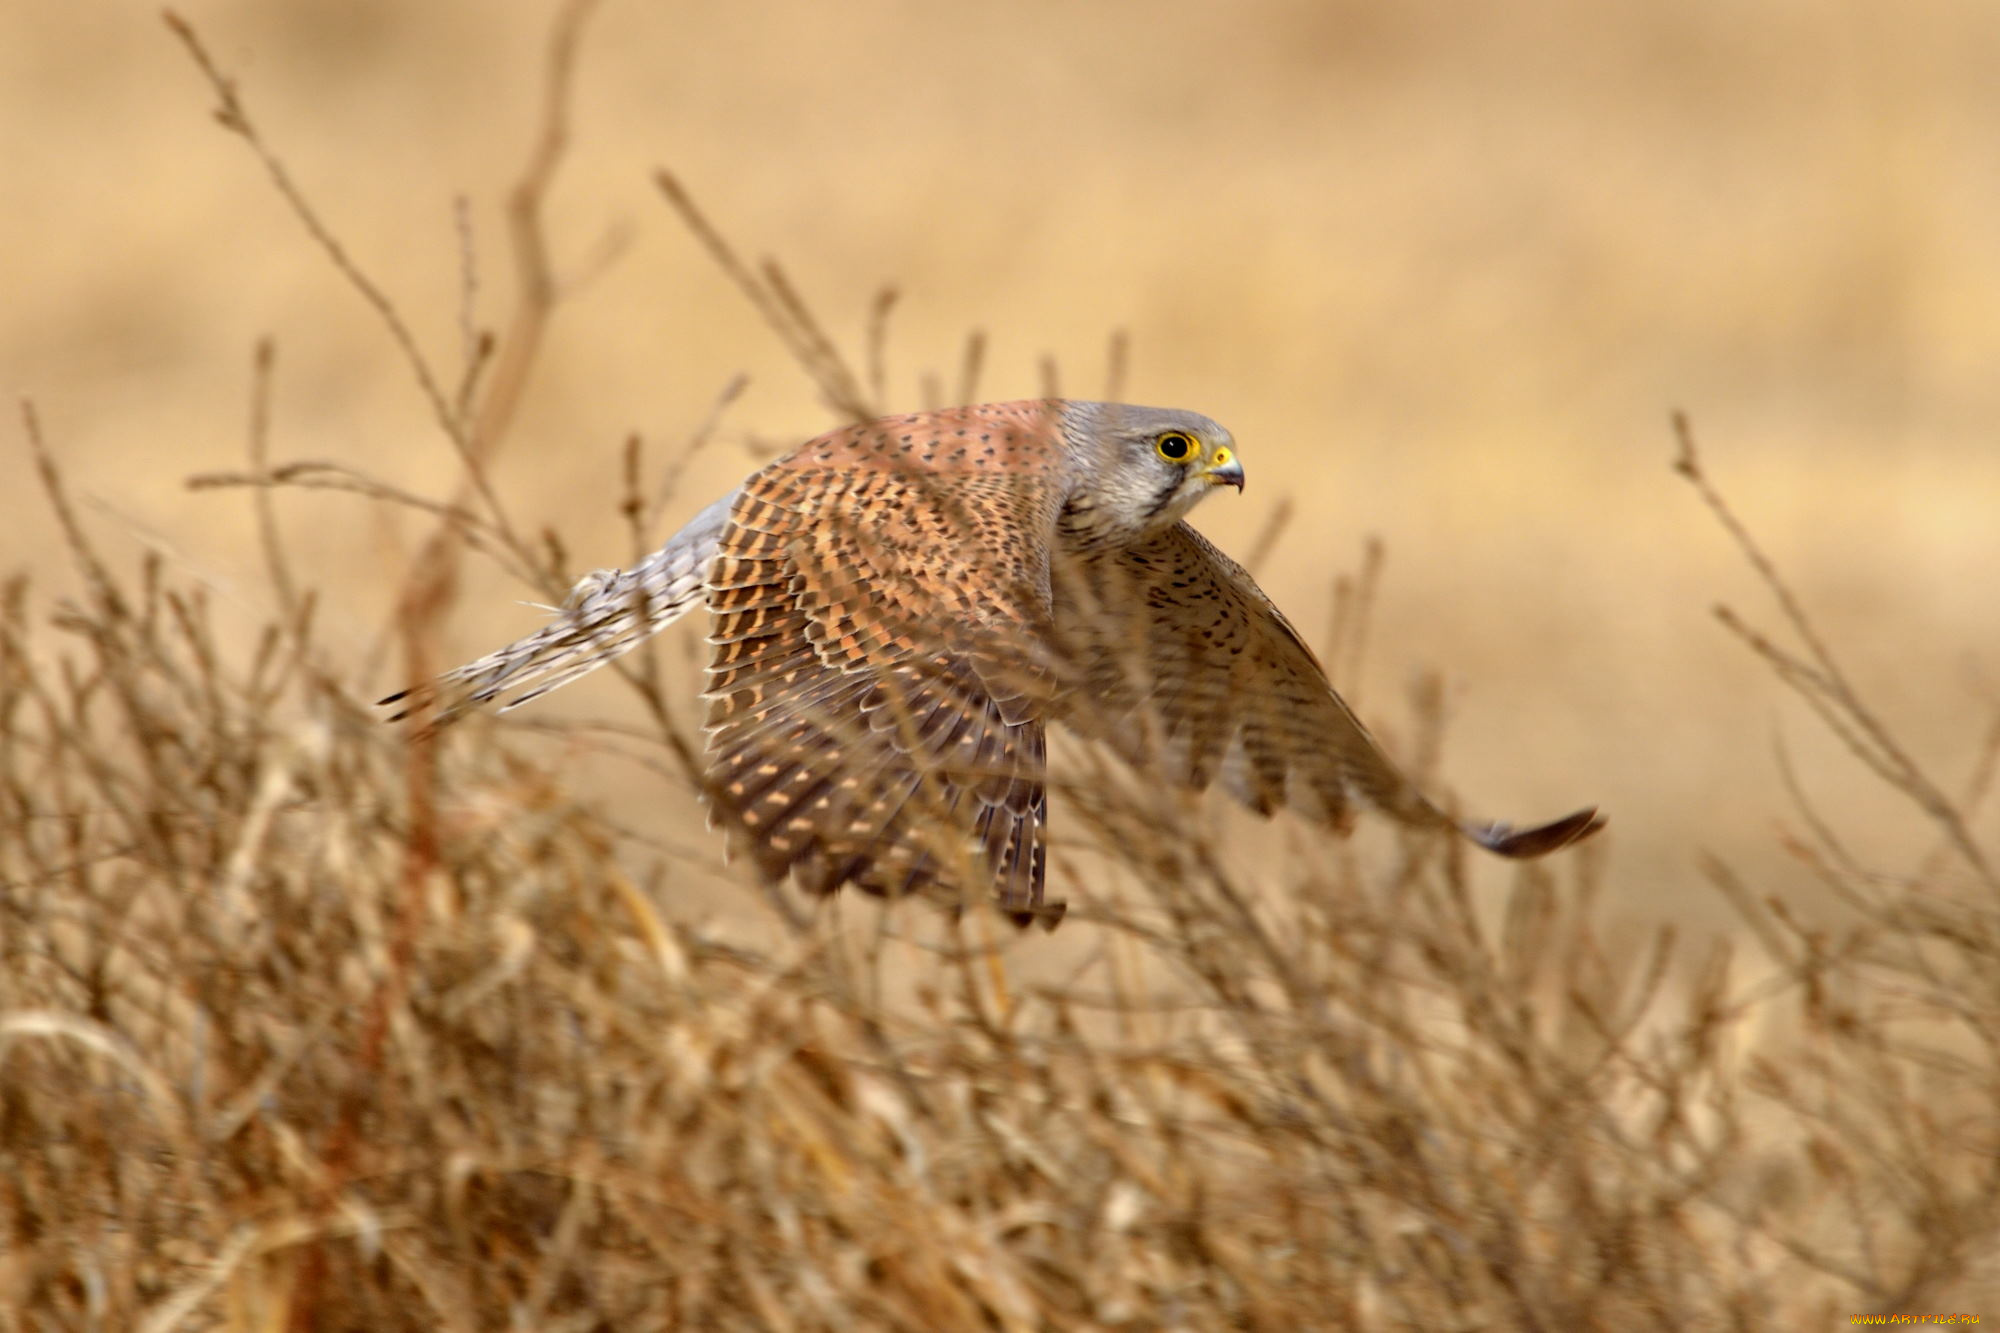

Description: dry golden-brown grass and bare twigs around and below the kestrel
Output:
[0,4,2000,1329]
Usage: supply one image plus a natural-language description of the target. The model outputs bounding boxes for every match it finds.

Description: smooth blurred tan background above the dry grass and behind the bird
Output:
[0,0,2000,928]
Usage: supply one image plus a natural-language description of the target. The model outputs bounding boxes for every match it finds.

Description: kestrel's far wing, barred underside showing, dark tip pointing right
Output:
[1054,522,1604,857]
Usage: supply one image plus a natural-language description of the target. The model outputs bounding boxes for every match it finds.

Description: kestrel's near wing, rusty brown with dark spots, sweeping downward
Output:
[706,404,1062,927]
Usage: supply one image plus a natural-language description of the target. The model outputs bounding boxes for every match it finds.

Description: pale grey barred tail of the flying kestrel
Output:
[382,490,738,727]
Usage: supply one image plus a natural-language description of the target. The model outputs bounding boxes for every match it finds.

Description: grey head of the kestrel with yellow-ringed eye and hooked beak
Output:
[1064,402,1244,536]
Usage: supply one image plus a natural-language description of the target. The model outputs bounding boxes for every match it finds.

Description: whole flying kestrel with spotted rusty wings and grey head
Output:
[382,400,1604,925]
